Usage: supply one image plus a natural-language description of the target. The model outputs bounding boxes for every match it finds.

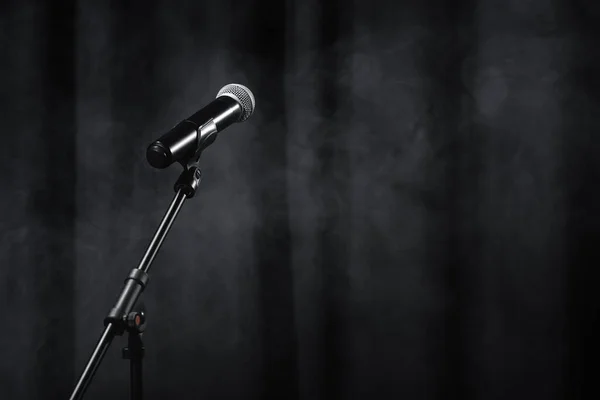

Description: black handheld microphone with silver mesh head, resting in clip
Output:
[146,83,256,169]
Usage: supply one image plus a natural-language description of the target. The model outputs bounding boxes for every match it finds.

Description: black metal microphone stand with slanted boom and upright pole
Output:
[69,161,202,400]
